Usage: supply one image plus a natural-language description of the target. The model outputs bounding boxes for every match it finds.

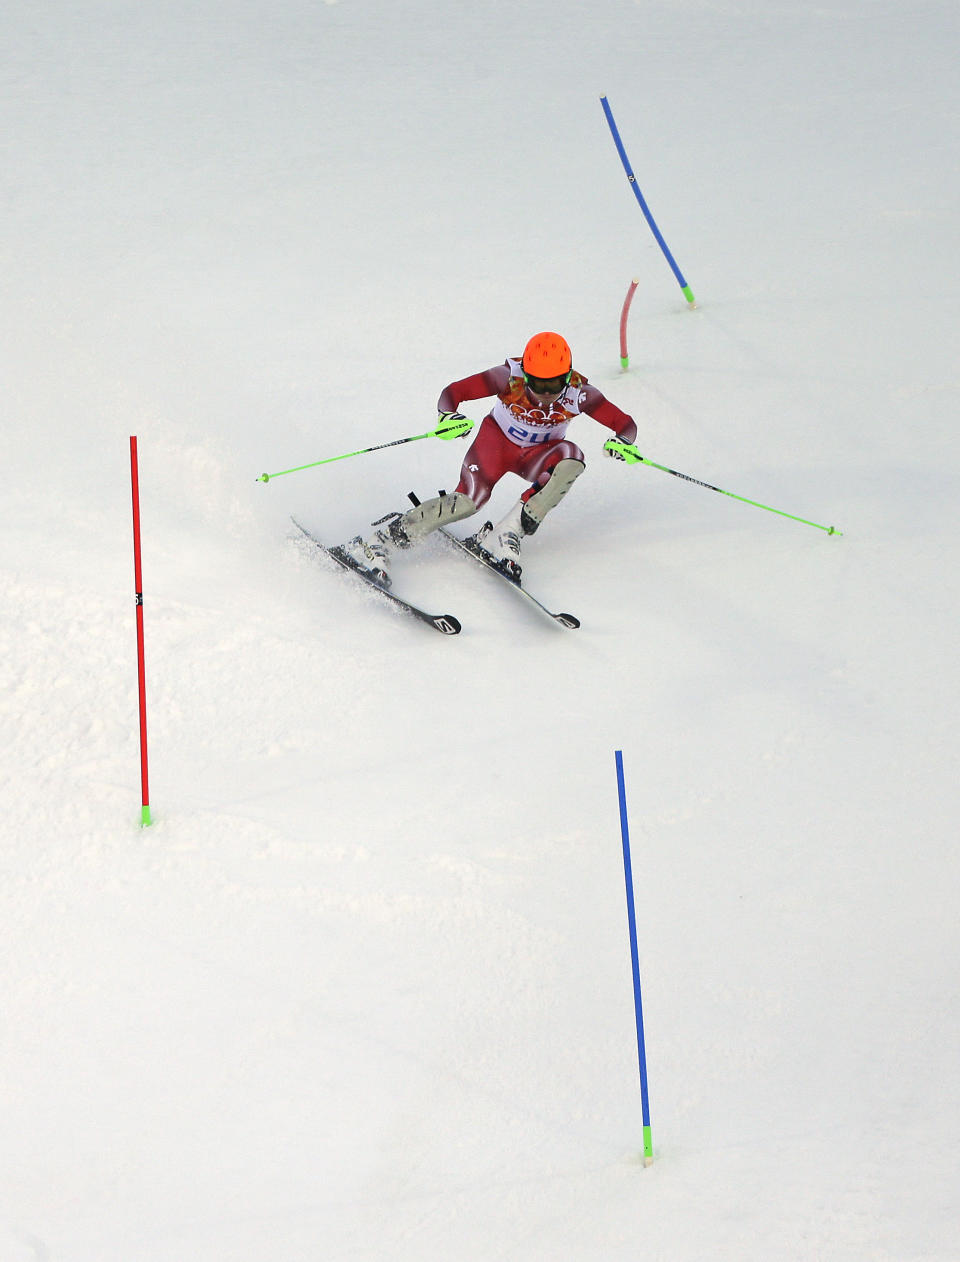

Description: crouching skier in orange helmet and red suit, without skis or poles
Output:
[343,332,637,587]
